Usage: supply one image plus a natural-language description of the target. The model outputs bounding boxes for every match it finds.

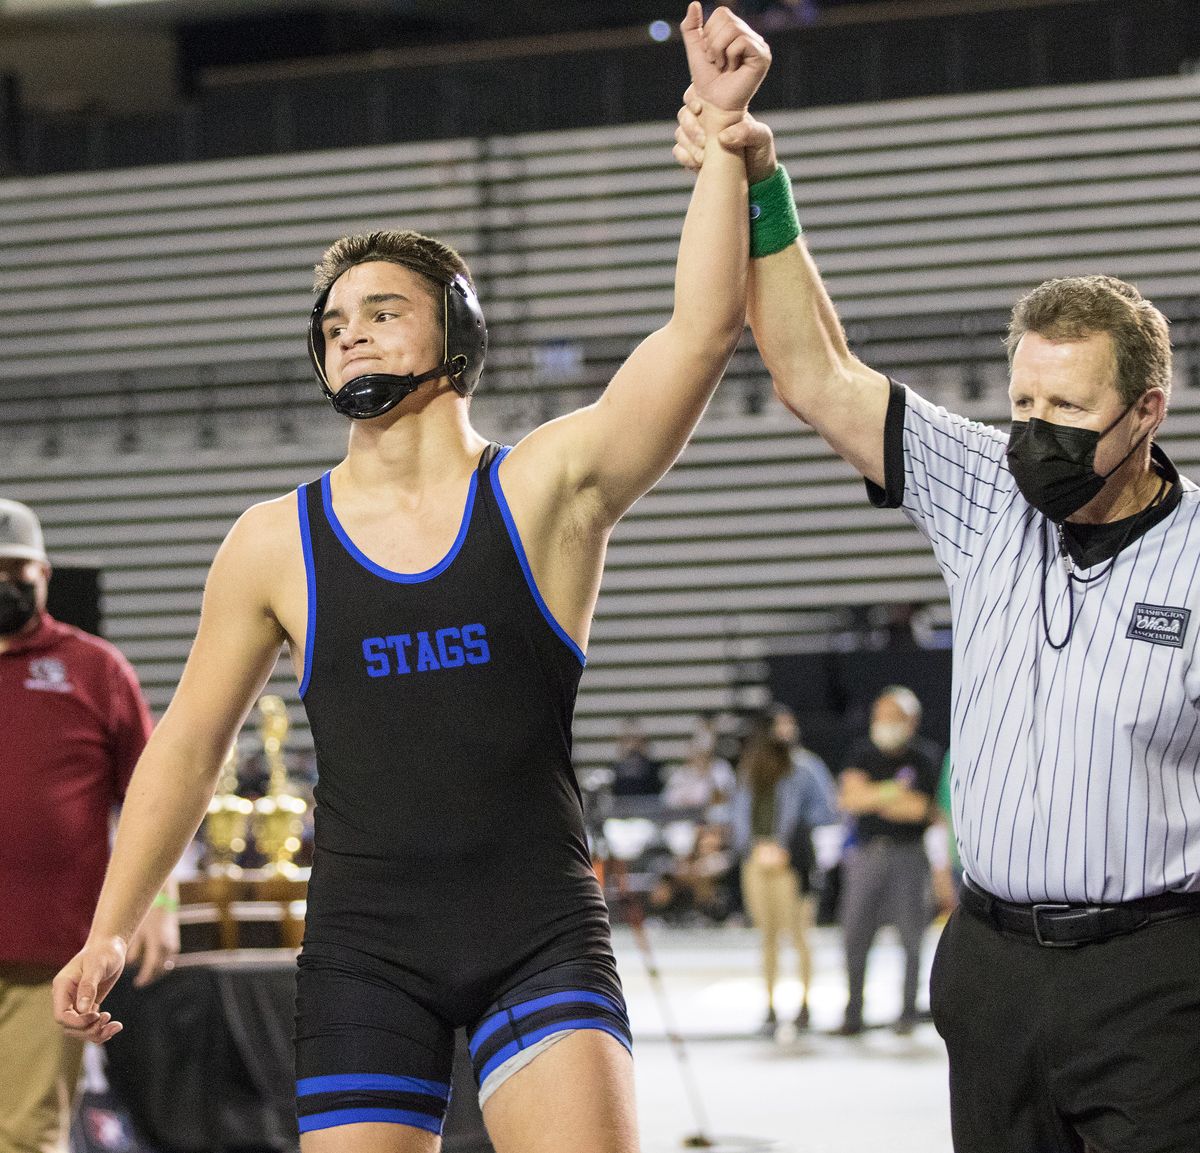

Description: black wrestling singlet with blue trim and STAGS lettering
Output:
[296,446,629,1133]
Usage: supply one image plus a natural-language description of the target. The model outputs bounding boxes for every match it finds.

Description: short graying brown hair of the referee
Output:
[1004,276,1171,406]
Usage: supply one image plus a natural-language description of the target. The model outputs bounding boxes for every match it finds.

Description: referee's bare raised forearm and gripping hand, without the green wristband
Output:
[674,106,888,485]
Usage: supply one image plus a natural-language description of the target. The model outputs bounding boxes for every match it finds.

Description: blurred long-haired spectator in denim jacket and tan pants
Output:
[732,707,838,1033]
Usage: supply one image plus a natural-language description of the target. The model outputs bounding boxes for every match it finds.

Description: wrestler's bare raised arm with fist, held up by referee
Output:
[506,2,770,526]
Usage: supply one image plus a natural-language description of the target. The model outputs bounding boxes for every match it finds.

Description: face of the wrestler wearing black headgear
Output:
[320,260,443,392]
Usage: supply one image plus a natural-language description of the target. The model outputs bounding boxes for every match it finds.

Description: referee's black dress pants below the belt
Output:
[930,908,1200,1153]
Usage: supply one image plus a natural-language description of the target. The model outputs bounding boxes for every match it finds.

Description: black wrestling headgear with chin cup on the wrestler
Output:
[308,267,487,420]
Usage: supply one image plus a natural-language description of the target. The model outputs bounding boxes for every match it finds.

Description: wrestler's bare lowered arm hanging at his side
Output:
[54,506,291,1041]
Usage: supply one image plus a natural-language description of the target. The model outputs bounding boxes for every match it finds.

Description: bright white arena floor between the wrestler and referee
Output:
[617,926,950,1153]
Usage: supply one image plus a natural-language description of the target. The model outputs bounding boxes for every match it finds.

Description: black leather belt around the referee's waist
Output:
[960,877,1200,948]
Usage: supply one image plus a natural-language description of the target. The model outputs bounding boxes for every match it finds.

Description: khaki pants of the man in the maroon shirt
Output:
[0,962,83,1153]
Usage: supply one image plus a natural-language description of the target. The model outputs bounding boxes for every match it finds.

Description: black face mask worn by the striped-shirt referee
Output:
[1008,404,1150,522]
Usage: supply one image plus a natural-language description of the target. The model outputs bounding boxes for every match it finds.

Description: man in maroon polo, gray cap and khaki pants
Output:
[0,499,179,1153]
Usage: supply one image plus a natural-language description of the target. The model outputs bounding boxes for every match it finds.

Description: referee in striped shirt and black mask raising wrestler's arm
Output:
[676,104,1200,1153]
